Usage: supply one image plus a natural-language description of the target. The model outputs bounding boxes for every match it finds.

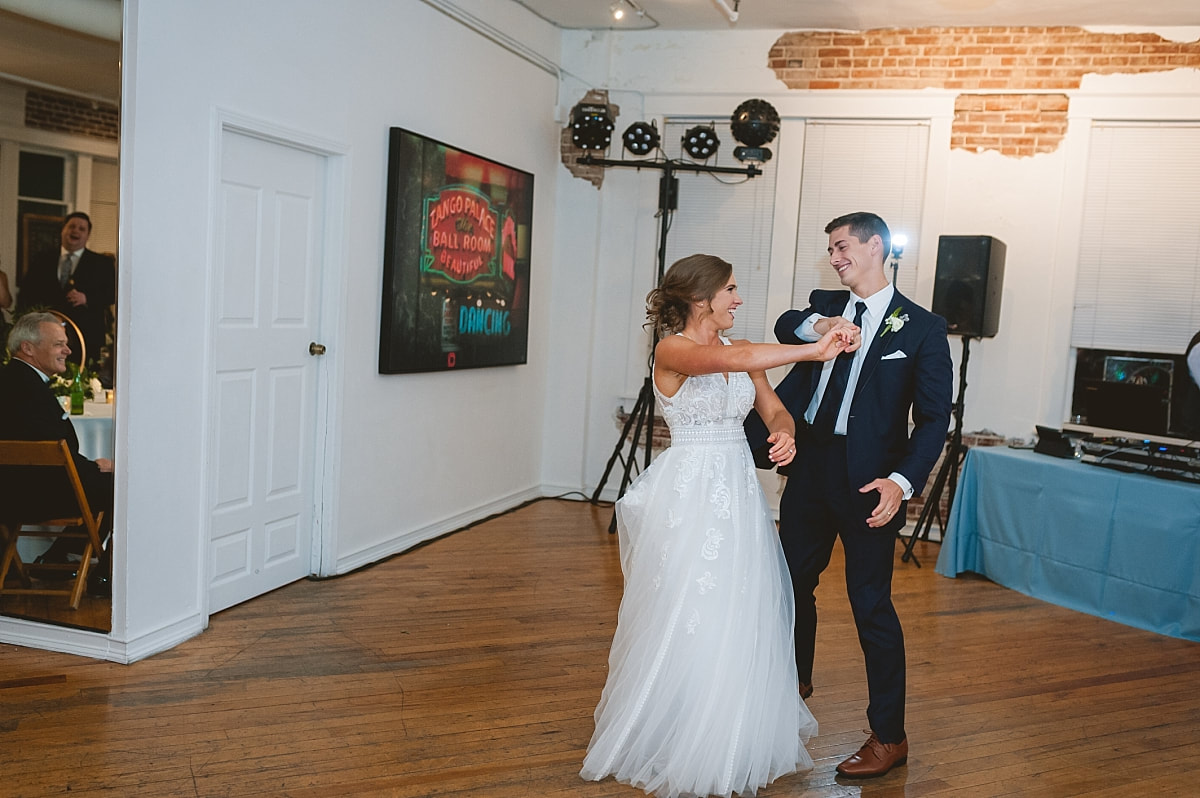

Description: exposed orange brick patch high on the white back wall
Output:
[768,28,1200,157]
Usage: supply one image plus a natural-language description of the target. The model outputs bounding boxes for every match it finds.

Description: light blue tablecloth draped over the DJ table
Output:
[937,448,1200,641]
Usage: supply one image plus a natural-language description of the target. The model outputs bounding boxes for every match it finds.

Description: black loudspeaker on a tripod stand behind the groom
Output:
[900,235,1006,568]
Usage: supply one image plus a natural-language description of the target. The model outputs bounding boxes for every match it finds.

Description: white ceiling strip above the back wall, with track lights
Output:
[512,0,1200,30]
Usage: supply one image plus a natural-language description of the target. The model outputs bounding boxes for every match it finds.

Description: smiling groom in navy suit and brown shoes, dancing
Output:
[746,212,952,778]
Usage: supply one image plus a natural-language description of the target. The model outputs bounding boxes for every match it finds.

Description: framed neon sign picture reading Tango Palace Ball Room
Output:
[379,127,533,374]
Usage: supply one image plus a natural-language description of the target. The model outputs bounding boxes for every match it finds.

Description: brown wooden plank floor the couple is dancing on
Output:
[0,500,1200,798]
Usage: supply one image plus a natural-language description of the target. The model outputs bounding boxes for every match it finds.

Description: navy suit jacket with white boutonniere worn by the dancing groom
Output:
[745,289,953,493]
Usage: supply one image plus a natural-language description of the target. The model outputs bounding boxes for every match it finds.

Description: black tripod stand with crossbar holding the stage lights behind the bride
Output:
[577,155,762,533]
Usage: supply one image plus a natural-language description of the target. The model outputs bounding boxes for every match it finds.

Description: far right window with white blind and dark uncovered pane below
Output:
[1072,122,1200,436]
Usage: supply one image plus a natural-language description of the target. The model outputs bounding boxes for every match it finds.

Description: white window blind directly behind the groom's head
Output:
[792,121,929,307]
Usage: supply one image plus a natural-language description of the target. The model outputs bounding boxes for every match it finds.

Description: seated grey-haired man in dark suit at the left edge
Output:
[0,313,113,572]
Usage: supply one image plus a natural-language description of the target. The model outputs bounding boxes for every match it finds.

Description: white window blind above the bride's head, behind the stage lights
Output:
[662,119,780,341]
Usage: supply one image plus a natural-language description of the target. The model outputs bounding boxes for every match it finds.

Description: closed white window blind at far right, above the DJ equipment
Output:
[1070,122,1200,354]
